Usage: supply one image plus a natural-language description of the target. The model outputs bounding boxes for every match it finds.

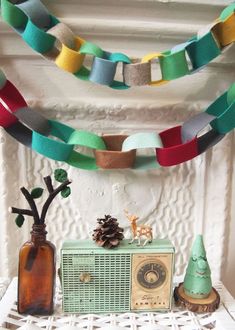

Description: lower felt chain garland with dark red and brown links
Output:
[0,71,235,170]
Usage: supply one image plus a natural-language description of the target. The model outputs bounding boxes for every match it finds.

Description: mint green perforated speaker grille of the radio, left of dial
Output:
[61,252,131,313]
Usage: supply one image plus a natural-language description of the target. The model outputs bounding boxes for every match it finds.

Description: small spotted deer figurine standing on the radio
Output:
[124,210,153,246]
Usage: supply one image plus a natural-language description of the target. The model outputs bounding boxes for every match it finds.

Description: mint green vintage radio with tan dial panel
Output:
[61,240,174,313]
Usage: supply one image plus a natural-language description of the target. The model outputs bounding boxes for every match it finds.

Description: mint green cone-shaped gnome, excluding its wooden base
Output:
[183,235,212,299]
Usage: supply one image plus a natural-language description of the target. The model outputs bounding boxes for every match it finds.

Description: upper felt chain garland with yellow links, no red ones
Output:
[1,0,235,89]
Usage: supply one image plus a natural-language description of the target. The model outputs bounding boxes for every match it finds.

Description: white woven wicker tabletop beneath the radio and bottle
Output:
[0,278,235,330]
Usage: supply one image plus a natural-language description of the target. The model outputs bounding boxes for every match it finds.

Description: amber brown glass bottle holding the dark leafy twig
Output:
[18,224,55,315]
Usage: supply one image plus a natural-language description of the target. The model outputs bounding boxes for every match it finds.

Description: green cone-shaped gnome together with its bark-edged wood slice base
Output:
[174,235,220,313]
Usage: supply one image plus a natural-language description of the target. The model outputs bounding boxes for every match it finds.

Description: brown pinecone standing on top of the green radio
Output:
[92,215,124,249]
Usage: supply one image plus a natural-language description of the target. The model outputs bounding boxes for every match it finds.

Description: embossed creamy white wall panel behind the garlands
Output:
[0,0,235,295]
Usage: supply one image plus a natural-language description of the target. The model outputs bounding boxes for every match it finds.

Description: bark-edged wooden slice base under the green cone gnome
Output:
[174,283,220,313]
